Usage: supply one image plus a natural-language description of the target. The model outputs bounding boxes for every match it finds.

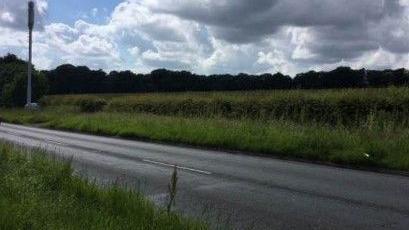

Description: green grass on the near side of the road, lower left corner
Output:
[0,143,207,230]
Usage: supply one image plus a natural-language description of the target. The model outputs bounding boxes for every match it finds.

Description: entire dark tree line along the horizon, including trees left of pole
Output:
[0,54,409,105]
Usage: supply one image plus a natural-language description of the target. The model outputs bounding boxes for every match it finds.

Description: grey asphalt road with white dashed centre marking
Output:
[0,123,409,230]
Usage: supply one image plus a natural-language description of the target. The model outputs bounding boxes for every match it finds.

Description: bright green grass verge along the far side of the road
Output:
[0,106,409,171]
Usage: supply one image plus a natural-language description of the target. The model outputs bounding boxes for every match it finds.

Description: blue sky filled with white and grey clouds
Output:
[0,0,409,76]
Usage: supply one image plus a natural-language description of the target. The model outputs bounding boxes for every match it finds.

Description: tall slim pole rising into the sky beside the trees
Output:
[26,1,34,107]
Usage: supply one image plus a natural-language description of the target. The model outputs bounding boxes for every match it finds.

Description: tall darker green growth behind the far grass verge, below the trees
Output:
[39,88,409,126]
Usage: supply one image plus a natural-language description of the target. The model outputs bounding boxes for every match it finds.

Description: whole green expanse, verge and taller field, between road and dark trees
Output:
[0,88,409,170]
